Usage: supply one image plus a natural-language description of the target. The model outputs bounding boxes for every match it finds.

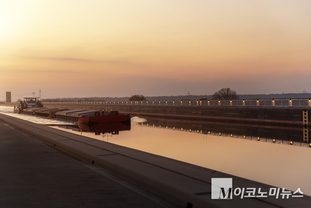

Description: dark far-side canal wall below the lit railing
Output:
[44,104,311,126]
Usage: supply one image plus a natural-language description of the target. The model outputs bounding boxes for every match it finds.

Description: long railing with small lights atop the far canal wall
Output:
[43,99,311,107]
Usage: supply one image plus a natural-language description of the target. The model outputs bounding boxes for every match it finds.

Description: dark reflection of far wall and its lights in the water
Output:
[141,117,311,147]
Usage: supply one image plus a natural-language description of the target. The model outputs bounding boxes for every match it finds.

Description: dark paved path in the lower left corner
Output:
[0,121,177,208]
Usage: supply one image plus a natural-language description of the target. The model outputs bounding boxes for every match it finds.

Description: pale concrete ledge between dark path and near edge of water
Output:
[0,114,311,208]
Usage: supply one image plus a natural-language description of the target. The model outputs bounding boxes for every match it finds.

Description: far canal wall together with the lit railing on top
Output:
[44,99,311,127]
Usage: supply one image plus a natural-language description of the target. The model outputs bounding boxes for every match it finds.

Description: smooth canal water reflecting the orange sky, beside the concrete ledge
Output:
[1,107,311,195]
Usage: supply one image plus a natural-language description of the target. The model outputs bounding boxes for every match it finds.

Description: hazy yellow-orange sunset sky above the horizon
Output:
[0,0,311,100]
